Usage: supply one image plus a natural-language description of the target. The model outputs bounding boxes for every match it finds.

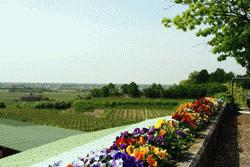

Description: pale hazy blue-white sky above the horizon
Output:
[0,0,245,84]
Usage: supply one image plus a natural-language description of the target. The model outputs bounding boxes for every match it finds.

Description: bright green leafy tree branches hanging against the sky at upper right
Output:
[162,0,250,72]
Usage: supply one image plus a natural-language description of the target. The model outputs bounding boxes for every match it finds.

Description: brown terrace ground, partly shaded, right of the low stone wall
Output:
[213,111,250,167]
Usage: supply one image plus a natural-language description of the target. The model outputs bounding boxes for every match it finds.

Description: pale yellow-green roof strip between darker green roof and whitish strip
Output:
[0,122,133,167]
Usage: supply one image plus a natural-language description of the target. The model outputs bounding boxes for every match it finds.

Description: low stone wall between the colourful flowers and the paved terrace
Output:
[177,107,230,167]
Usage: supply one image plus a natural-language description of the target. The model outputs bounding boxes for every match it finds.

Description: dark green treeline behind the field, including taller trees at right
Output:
[90,68,235,98]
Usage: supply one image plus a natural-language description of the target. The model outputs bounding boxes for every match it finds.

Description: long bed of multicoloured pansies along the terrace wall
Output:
[50,97,222,167]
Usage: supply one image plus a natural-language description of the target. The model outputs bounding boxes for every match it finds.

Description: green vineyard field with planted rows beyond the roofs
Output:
[0,92,190,131]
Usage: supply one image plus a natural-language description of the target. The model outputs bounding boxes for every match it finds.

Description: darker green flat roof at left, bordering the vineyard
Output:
[0,119,84,151]
